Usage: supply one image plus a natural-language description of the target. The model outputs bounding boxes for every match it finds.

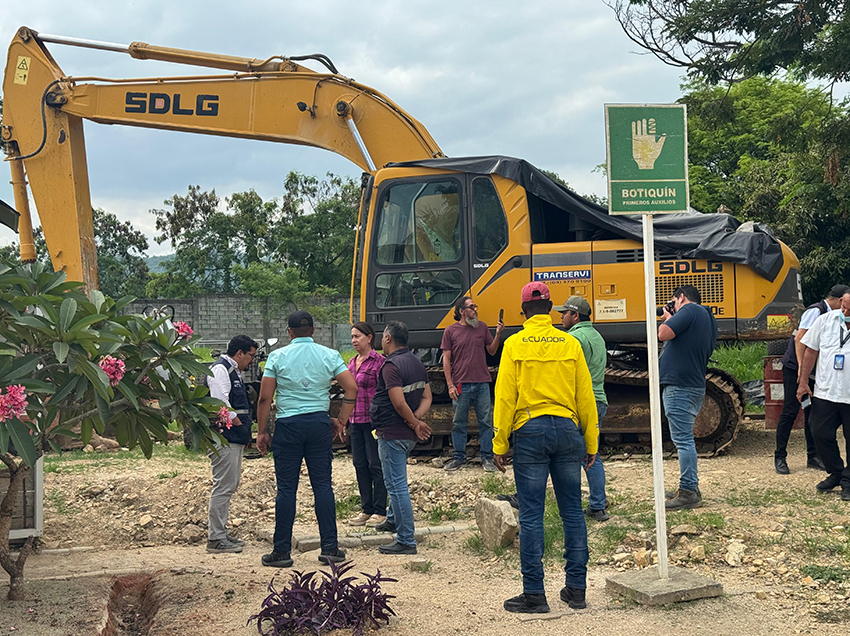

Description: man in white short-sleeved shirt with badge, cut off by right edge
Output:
[797,293,850,501]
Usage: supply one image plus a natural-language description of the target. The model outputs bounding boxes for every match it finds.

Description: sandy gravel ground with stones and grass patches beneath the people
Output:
[0,422,850,636]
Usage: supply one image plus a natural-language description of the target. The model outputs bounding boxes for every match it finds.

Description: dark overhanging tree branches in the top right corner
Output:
[604,0,850,84]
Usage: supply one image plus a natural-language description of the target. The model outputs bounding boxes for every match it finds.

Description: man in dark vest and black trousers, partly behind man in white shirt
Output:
[773,285,850,475]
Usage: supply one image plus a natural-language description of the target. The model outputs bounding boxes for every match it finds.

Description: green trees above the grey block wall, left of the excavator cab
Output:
[147,172,360,306]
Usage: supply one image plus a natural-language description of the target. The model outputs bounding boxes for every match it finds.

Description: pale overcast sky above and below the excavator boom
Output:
[0,0,680,254]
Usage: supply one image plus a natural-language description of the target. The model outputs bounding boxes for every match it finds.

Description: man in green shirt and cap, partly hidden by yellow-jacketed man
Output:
[555,296,609,521]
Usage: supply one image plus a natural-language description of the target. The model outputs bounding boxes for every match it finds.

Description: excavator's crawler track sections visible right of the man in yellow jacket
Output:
[601,367,745,457]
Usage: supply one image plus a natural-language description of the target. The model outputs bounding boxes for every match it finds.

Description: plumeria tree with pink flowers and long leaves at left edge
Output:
[0,263,222,600]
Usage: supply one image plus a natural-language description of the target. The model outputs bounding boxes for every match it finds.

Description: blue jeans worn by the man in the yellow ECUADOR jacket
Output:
[513,415,588,594]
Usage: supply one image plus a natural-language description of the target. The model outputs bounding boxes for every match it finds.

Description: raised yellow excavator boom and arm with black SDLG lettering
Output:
[2,28,443,287]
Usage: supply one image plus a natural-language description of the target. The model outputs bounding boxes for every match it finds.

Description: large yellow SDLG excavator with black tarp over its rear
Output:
[2,28,802,454]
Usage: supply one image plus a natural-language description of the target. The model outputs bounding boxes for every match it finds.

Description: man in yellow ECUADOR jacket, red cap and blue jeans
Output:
[493,281,599,614]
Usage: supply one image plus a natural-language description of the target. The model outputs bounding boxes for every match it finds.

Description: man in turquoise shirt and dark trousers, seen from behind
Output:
[257,311,357,568]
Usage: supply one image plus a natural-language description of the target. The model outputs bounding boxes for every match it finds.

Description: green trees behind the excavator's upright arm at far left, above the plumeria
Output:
[0,208,150,298]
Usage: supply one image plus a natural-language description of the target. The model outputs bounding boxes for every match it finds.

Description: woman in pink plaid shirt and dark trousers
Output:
[348,322,387,527]
